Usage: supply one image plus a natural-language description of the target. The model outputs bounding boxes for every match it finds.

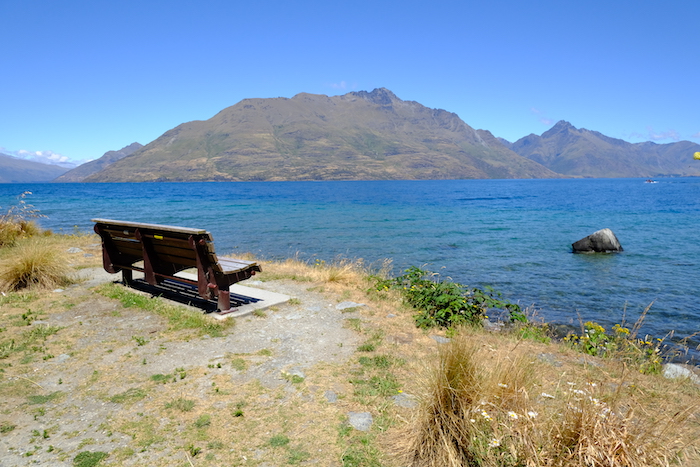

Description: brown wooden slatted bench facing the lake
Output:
[92,219,262,312]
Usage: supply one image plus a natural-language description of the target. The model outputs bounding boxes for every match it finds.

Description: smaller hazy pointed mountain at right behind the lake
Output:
[505,120,700,178]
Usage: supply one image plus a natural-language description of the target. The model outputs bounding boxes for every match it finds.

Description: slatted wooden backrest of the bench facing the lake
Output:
[92,219,221,274]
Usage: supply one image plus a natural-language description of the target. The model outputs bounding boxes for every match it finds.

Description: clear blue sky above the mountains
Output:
[0,0,700,166]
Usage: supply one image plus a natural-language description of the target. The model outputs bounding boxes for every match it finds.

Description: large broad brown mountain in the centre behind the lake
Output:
[84,88,559,182]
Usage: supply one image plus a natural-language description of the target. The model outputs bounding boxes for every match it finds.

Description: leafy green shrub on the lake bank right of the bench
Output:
[376,266,527,328]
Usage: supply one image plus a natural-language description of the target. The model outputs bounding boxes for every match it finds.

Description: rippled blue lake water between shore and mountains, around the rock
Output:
[0,178,700,354]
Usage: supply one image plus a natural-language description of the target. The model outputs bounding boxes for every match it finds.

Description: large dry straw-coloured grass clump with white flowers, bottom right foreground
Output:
[400,333,698,467]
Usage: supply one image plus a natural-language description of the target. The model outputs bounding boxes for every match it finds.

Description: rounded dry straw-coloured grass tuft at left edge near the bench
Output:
[0,237,71,291]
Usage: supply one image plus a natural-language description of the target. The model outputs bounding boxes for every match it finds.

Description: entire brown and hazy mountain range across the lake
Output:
[0,88,700,183]
